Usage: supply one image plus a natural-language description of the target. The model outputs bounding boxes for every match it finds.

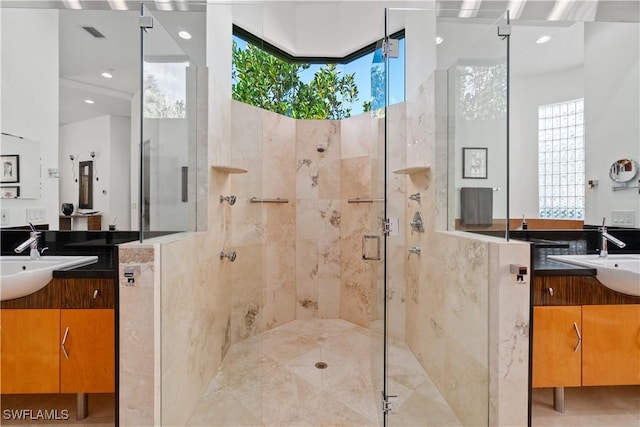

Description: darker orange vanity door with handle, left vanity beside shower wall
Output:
[60,309,115,393]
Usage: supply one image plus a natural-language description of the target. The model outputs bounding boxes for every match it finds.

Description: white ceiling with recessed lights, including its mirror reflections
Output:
[11,0,640,123]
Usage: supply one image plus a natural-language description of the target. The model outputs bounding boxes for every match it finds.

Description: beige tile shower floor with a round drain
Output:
[188,320,461,427]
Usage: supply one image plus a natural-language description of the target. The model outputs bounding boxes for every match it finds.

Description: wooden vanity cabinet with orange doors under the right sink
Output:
[532,276,640,387]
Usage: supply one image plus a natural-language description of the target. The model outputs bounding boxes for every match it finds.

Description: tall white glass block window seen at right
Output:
[538,98,585,219]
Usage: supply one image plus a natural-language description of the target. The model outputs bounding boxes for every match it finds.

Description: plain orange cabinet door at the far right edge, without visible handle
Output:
[582,304,640,385]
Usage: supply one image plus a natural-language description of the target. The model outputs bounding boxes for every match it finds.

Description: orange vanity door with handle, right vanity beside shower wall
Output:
[532,306,582,387]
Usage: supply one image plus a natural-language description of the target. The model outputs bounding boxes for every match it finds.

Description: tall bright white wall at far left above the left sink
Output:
[0,9,59,229]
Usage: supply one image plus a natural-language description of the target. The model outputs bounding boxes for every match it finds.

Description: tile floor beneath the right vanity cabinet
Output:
[531,386,640,427]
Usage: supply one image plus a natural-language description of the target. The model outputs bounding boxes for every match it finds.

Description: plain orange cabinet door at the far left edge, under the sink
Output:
[0,309,60,394]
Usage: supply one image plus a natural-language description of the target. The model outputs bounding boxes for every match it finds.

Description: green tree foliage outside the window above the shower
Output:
[232,41,371,120]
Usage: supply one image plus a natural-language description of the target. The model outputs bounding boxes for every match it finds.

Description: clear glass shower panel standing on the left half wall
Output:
[142,6,198,233]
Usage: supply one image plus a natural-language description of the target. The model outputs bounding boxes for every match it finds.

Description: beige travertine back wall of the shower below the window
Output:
[228,101,392,332]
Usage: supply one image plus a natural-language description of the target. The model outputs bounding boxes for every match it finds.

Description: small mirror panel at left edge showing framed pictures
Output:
[0,133,40,199]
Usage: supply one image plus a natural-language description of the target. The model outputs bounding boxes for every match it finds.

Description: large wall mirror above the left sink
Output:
[0,1,207,231]
